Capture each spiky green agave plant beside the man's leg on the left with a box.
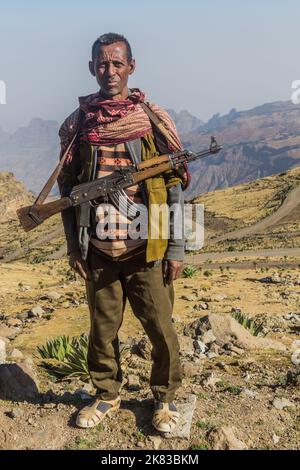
[37,334,89,378]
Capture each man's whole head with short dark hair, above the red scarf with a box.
[89,33,135,99]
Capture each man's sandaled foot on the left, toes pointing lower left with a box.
[76,397,121,428]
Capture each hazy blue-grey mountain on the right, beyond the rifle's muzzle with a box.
[181,102,300,199]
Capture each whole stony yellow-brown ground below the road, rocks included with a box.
[0,259,300,450]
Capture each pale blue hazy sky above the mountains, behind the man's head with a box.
[0,0,300,130]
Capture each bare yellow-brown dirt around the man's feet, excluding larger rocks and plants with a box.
[0,260,300,450]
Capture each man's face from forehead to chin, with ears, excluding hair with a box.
[89,42,135,98]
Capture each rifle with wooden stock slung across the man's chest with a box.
[17,136,222,232]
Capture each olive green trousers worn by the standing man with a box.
[86,249,181,402]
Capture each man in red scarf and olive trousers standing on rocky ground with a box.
[58,33,188,432]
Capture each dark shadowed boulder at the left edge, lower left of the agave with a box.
[0,363,39,401]
